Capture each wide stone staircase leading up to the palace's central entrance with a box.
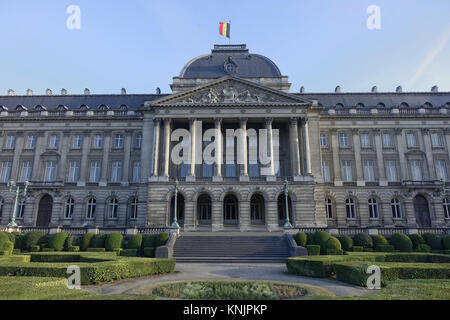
[173,232,289,263]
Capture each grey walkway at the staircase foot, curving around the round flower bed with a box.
[83,263,374,296]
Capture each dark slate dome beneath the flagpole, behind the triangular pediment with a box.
[179,44,282,79]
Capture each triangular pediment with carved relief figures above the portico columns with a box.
[150,77,313,105]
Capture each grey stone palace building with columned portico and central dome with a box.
[0,45,450,233]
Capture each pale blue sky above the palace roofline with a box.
[0,0,450,95]
